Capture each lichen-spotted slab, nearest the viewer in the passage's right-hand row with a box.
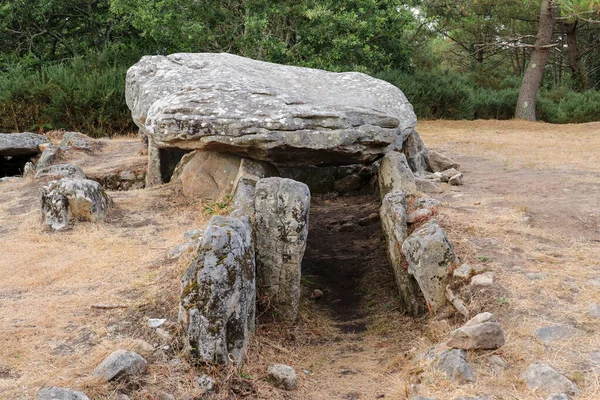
[402,220,458,312]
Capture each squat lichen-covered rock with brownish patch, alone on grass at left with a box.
[41,178,112,231]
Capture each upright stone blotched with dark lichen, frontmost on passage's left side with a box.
[179,216,256,364]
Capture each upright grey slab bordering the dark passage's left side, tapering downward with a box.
[254,178,310,322]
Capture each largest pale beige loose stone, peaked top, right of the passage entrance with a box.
[446,312,506,350]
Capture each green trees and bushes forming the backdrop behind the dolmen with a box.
[0,0,600,136]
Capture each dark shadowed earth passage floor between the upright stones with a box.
[302,195,387,333]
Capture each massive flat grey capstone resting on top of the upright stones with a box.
[126,53,418,183]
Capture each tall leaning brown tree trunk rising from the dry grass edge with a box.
[515,0,556,121]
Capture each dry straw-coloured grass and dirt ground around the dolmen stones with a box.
[0,121,600,400]
